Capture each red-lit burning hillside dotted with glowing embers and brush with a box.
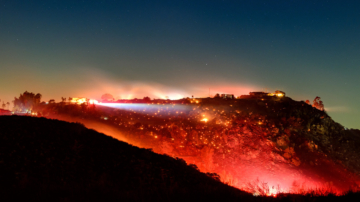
[31,94,360,195]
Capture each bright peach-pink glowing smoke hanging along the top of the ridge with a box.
[74,69,259,100]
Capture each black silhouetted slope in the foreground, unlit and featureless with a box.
[0,116,251,201]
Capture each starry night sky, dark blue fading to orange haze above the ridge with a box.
[0,0,360,128]
